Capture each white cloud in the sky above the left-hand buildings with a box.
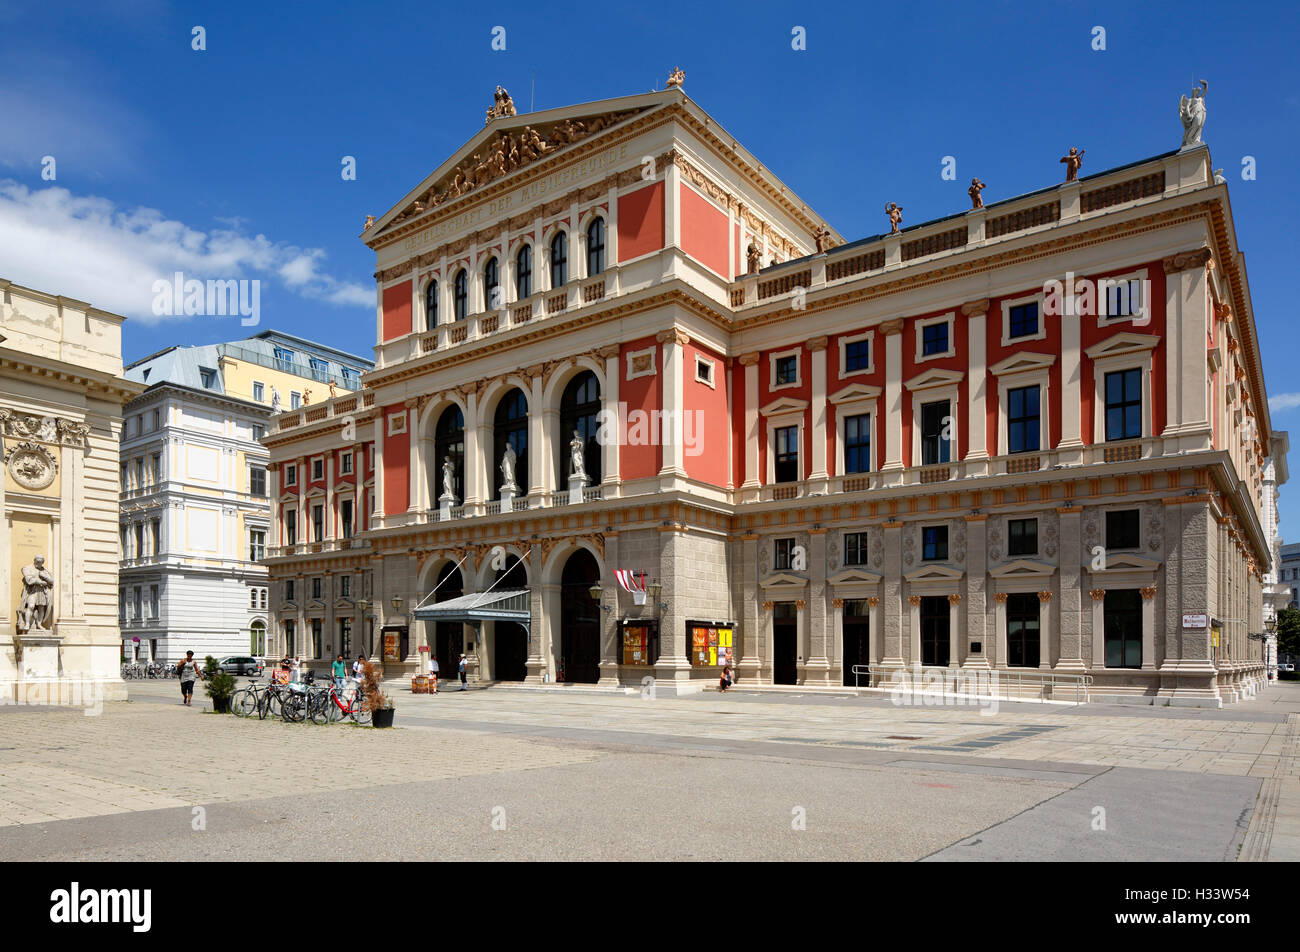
[0,179,374,323]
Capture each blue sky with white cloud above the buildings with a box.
[0,0,1300,528]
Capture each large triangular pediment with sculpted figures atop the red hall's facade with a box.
[361,90,677,241]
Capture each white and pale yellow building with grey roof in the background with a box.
[118,330,372,661]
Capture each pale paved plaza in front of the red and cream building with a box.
[0,681,1300,861]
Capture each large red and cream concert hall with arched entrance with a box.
[265,88,1270,705]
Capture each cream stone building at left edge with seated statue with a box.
[0,280,143,706]
